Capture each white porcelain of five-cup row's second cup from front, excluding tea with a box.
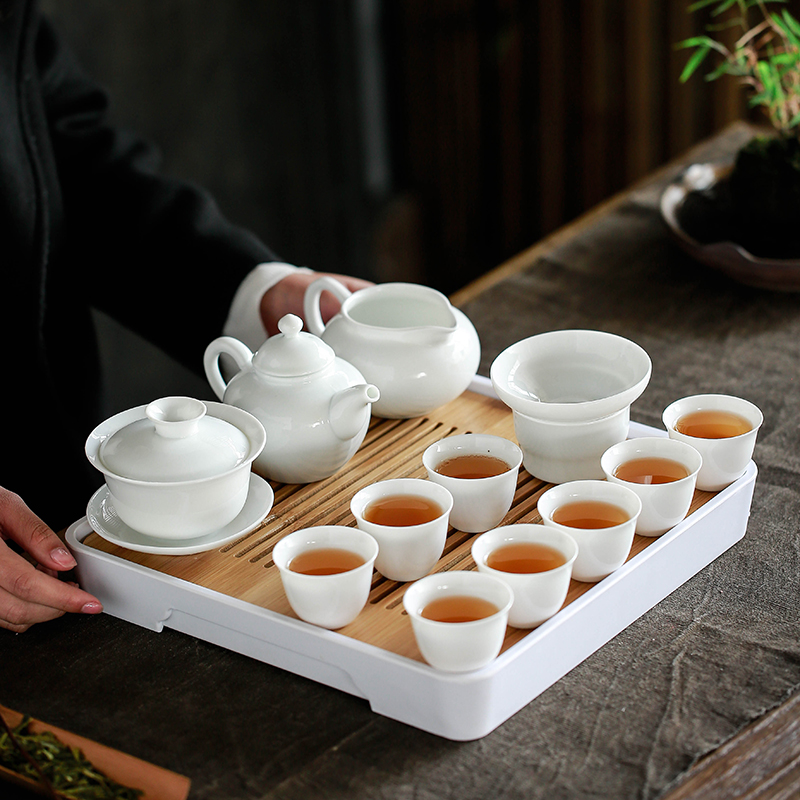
[472,523,578,628]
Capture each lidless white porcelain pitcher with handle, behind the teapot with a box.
[304,276,481,418]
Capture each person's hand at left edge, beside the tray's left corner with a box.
[0,486,103,633]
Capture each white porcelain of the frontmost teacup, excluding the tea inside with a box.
[403,570,514,672]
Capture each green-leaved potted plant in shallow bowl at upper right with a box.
[662,0,800,288]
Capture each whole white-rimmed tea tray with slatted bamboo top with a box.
[66,378,757,741]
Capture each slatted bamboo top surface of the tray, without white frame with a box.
[84,382,714,661]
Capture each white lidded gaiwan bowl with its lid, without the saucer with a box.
[85,397,266,539]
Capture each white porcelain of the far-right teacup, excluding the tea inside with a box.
[662,394,764,492]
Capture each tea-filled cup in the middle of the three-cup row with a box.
[350,478,453,581]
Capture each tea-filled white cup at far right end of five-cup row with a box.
[662,394,764,492]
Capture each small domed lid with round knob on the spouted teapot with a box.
[253,314,336,378]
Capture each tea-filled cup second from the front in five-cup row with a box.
[472,523,578,628]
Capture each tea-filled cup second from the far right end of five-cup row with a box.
[600,436,703,536]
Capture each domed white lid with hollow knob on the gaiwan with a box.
[98,397,250,482]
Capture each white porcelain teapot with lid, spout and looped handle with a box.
[203,314,380,483]
